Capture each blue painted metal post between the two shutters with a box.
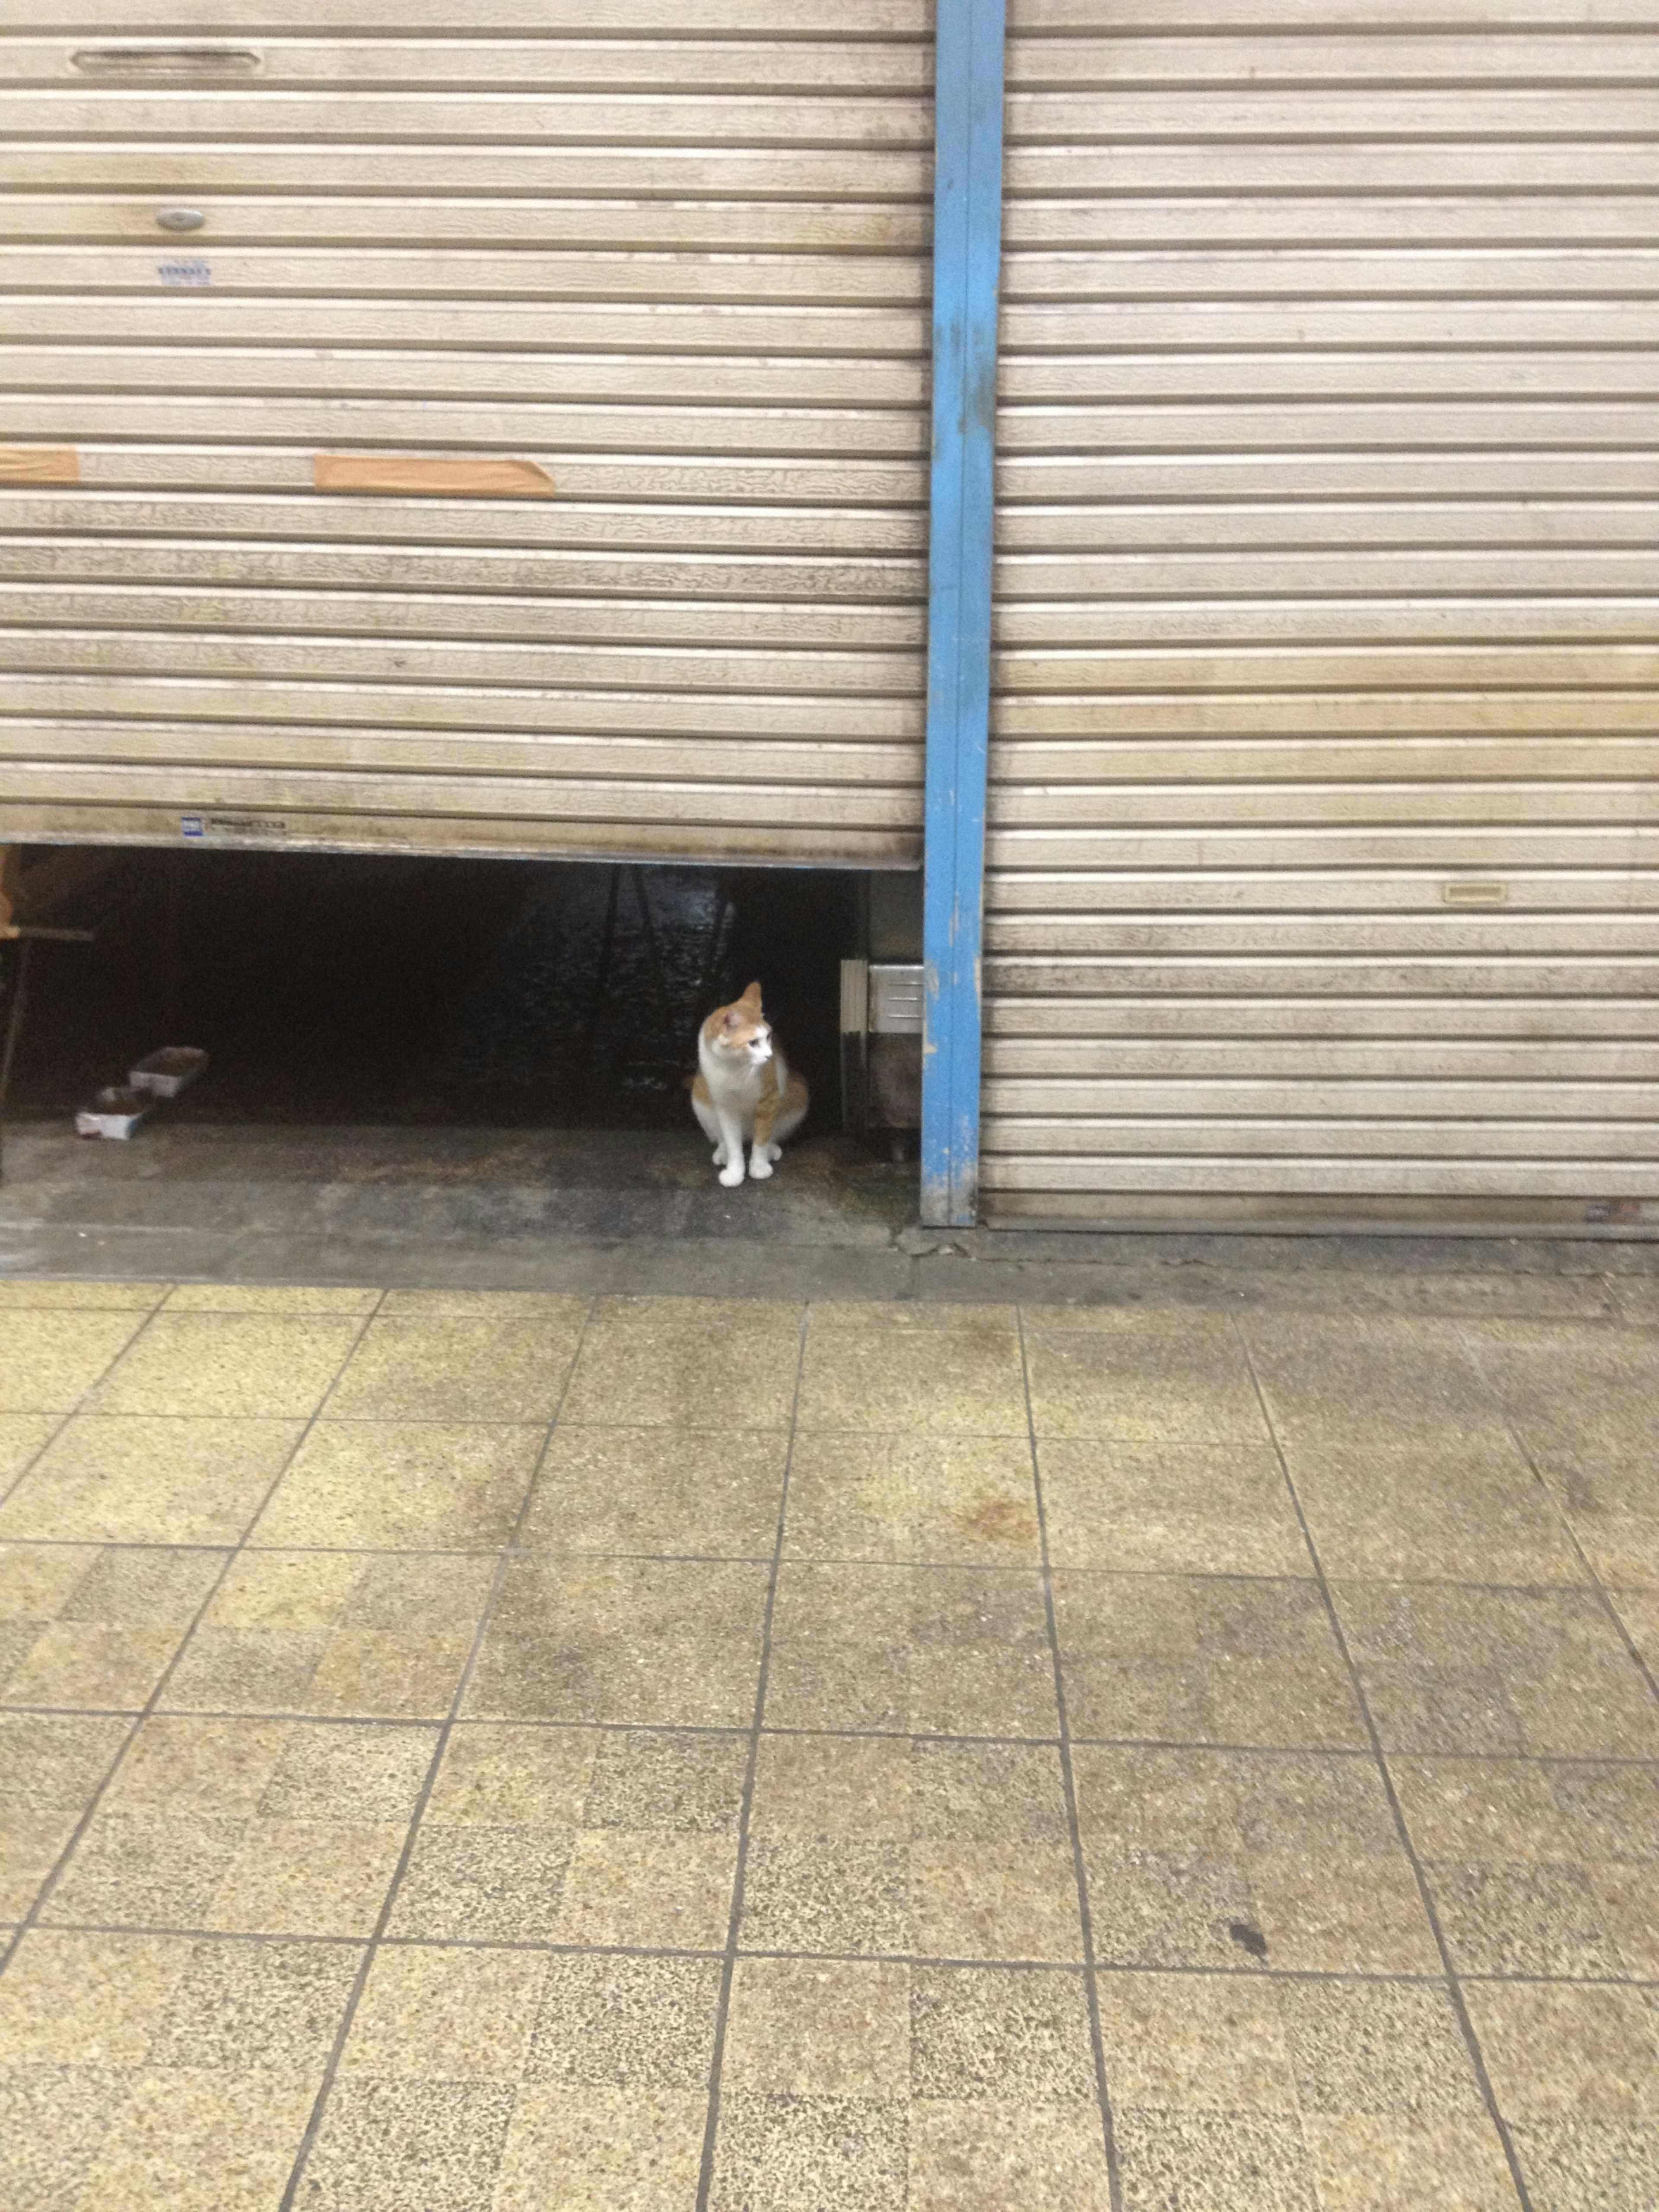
[922,0,1004,1225]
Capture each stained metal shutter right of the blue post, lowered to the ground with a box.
[984,0,1659,1221]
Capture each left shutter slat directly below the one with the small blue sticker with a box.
[6,299,938,354]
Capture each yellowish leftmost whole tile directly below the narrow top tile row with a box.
[93,1312,363,1420]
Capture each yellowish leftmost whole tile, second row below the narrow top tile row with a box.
[0,1414,303,1544]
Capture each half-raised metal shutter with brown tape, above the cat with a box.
[0,0,931,867]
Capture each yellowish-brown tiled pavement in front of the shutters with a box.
[0,1283,1659,2212]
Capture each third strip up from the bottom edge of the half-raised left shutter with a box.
[4,672,922,745]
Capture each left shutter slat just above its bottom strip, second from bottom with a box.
[0,717,920,788]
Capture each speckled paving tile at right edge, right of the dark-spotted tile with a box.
[1389,1758,1659,1977]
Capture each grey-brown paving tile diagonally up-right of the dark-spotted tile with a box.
[1332,1582,1659,1758]
